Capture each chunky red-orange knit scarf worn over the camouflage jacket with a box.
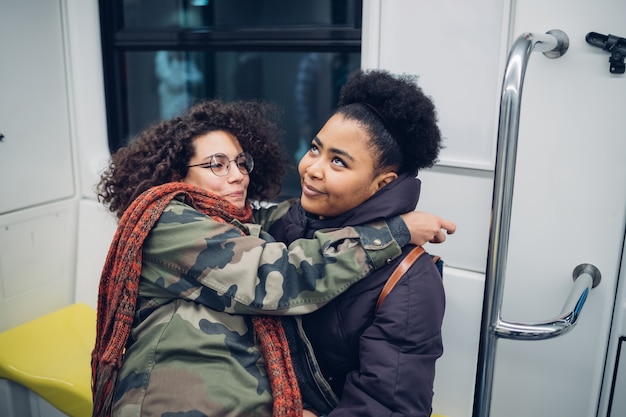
[91,182,302,417]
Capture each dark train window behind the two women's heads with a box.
[100,0,362,196]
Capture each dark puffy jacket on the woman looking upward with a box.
[270,176,445,417]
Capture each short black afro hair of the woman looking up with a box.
[336,70,442,174]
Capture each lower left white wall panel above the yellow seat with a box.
[0,200,77,331]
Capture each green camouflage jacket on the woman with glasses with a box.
[113,200,401,417]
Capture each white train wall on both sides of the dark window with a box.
[0,0,626,417]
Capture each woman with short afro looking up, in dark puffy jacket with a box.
[270,70,445,417]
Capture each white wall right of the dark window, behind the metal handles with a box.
[364,0,626,417]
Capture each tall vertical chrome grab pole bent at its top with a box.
[473,30,569,417]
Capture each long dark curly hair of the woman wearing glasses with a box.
[96,100,287,218]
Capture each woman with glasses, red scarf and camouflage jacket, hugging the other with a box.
[92,100,450,417]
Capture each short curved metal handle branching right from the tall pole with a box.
[494,264,601,340]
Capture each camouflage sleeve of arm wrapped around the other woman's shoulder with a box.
[143,206,401,314]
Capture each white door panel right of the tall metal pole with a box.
[491,0,626,417]
